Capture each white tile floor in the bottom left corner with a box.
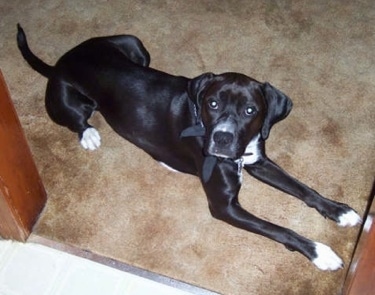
[0,240,198,295]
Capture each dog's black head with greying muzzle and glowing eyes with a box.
[188,73,292,159]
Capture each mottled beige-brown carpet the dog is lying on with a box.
[0,0,375,295]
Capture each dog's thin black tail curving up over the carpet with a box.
[17,24,53,78]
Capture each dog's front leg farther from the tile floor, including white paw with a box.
[244,156,361,226]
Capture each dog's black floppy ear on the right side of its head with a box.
[261,82,293,140]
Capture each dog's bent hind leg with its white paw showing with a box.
[46,78,100,150]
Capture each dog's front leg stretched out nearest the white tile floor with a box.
[202,160,342,270]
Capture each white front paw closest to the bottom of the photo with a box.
[312,242,344,270]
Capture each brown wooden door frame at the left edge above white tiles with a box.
[0,69,47,242]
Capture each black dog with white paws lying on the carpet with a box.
[17,26,361,270]
